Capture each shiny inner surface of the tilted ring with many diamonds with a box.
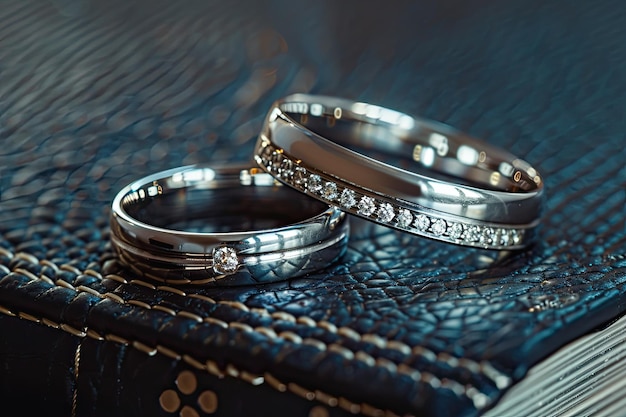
[283,103,541,192]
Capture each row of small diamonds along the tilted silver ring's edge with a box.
[260,145,524,247]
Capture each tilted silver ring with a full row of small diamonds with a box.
[255,94,543,250]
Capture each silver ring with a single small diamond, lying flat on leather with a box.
[111,166,349,285]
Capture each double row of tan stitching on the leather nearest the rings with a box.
[0,248,512,389]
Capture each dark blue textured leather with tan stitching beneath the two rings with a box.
[0,0,626,416]
